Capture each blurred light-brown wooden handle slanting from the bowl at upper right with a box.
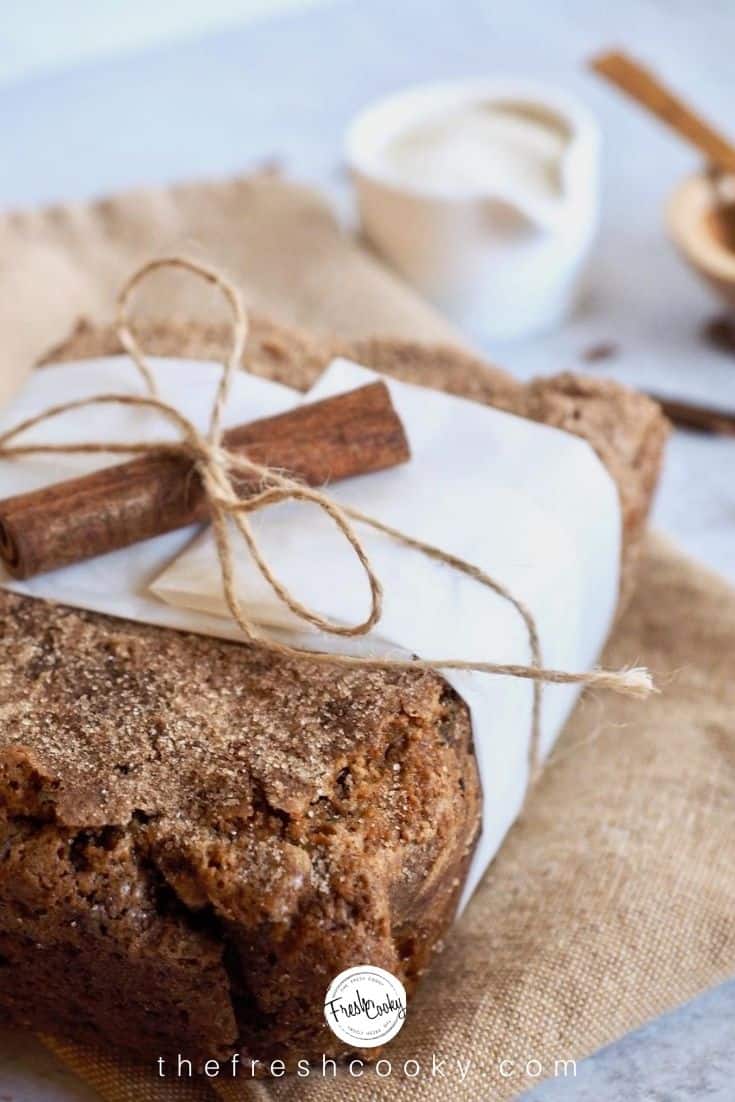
[590,50,735,172]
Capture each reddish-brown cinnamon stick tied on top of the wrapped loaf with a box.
[0,382,410,579]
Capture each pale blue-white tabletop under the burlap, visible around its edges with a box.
[0,0,735,1102]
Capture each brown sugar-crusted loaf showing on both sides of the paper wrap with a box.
[0,321,666,1061]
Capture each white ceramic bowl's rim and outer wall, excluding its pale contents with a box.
[346,80,601,339]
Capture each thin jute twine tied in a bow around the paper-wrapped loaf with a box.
[0,256,655,780]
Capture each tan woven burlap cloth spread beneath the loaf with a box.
[0,180,735,1102]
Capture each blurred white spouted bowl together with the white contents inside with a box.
[347,83,599,338]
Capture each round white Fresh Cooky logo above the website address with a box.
[324,964,406,1048]
